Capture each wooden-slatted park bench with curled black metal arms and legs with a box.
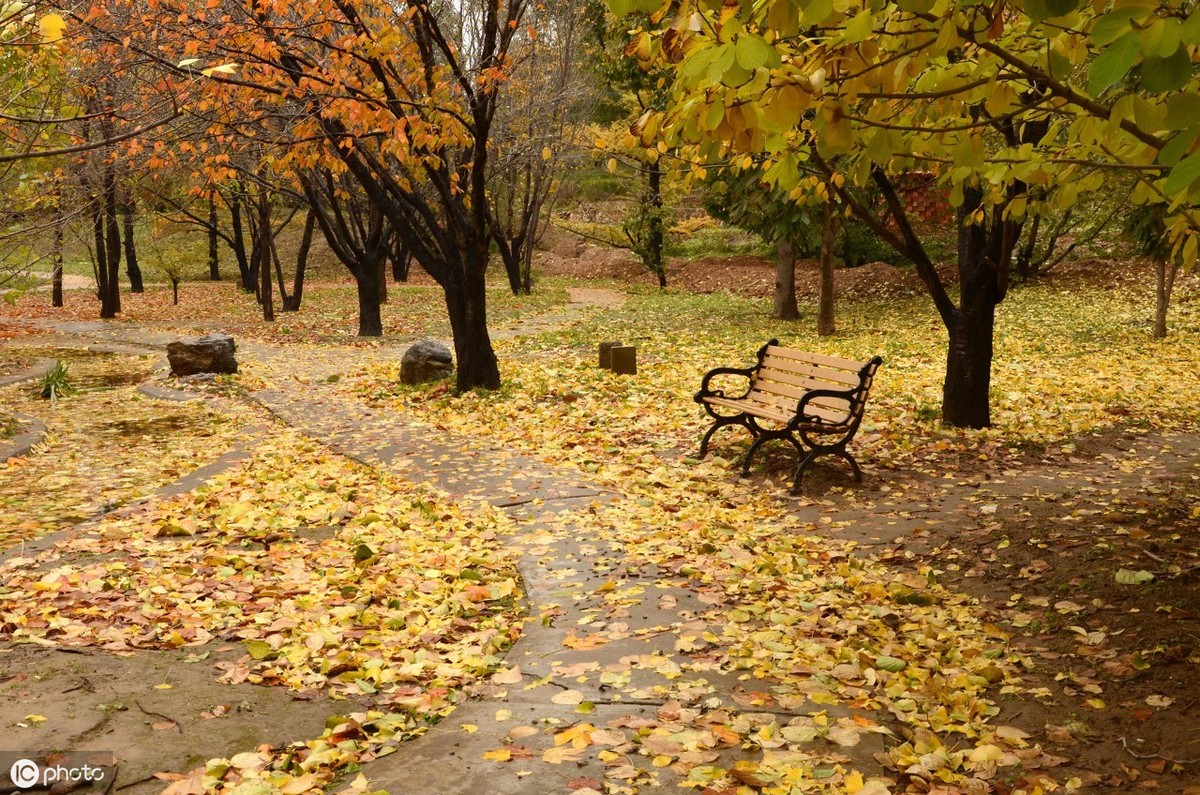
[696,340,883,494]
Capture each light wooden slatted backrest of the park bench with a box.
[750,340,882,425]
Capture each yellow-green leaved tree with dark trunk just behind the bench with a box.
[628,0,1200,428]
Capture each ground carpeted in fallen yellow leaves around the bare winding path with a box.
[0,256,1200,795]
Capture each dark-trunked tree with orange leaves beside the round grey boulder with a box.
[120,0,527,389]
